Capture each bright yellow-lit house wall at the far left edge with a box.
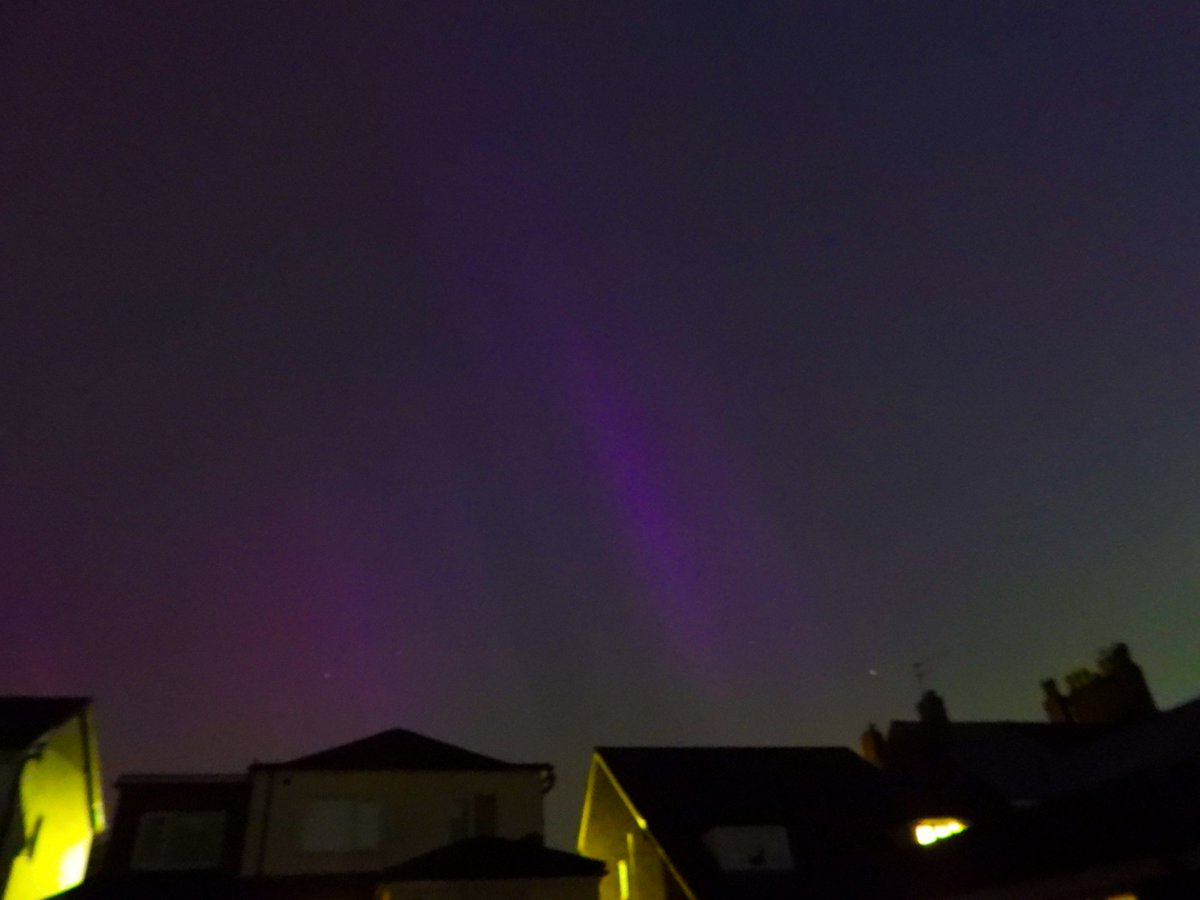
[4,718,103,900]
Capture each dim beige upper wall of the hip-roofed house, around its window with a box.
[242,769,544,875]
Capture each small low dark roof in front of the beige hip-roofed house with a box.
[380,838,605,882]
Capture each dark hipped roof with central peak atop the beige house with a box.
[259,728,553,772]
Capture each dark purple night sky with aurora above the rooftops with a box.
[0,0,1200,845]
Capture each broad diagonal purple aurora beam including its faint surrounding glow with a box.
[388,37,820,677]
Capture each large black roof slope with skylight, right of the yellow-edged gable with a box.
[596,746,920,899]
